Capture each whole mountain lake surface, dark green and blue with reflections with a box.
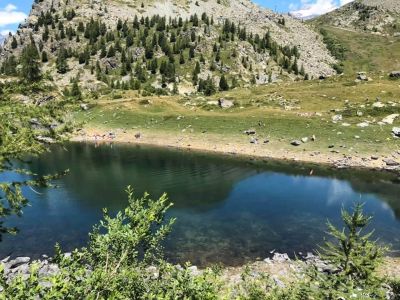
[0,143,400,266]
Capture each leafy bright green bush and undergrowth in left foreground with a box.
[0,188,218,299]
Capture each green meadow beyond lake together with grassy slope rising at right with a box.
[76,27,400,163]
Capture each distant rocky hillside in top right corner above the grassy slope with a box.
[312,0,400,37]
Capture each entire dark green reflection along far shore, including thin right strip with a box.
[28,143,400,218]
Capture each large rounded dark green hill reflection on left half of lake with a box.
[32,144,257,210]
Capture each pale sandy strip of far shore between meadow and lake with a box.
[70,127,400,175]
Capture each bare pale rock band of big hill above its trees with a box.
[18,0,335,76]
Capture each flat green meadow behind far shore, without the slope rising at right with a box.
[77,78,400,159]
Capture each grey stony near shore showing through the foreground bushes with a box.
[0,251,400,290]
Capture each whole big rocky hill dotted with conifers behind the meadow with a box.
[0,0,336,94]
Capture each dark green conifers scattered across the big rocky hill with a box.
[0,7,306,94]
